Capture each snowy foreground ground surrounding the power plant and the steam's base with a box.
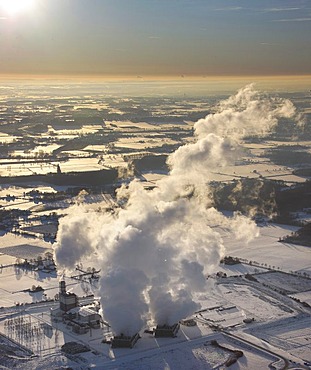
[0,224,311,370]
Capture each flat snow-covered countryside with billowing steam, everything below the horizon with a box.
[0,81,311,370]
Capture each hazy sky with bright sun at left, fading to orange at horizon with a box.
[0,0,311,77]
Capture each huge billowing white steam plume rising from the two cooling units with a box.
[55,85,295,335]
